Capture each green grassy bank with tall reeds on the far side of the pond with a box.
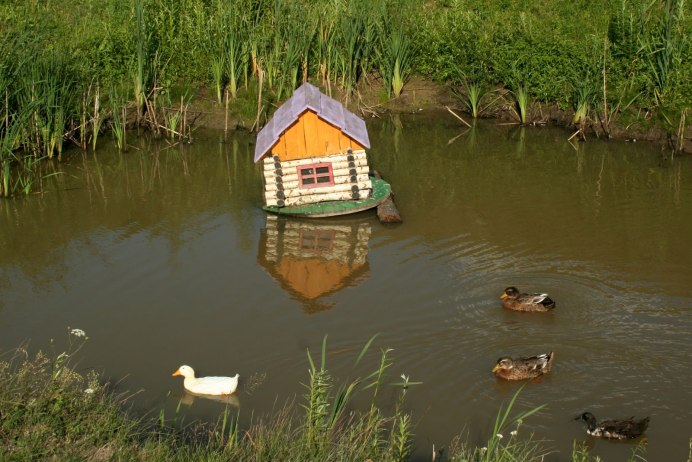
[0,0,692,196]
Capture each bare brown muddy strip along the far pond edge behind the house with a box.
[190,77,692,153]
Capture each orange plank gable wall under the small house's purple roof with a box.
[271,111,364,161]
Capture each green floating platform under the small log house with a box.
[262,177,392,218]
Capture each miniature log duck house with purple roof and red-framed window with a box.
[255,83,373,207]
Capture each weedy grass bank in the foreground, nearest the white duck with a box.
[0,329,676,462]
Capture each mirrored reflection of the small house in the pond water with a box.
[257,214,371,313]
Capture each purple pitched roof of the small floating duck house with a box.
[255,83,370,162]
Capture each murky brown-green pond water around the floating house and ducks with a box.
[0,114,692,461]
